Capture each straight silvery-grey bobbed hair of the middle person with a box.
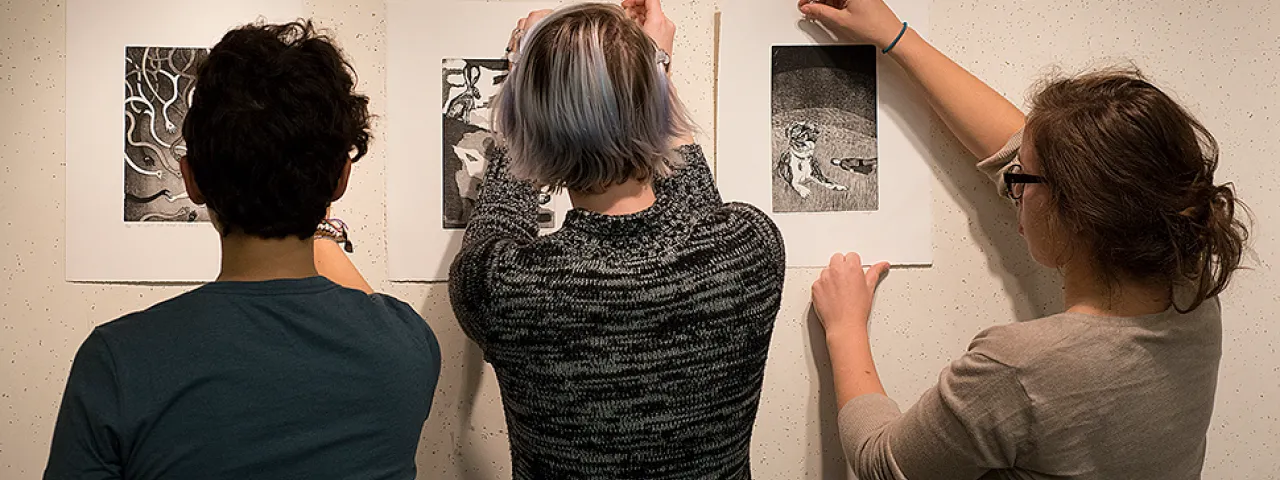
[493,4,692,193]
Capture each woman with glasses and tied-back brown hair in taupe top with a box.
[800,0,1248,480]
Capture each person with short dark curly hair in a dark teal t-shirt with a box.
[45,22,440,479]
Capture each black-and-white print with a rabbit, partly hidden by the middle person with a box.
[440,59,553,229]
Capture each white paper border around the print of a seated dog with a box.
[716,0,933,268]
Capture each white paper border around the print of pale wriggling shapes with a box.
[65,0,306,282]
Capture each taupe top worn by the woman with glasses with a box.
[840,134,1222,480]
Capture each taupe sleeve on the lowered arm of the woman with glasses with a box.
[840,351,1032,480]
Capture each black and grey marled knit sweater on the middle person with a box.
[449,146,786,479]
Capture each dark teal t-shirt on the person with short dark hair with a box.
[45,276,440,480]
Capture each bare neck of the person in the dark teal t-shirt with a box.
[216,233,319,282]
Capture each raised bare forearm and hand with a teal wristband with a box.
[800,0,1025,159]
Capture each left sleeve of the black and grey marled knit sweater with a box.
[449,148,538,348]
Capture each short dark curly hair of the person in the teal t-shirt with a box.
[182,20,370,238]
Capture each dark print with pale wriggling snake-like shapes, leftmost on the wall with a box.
[122,46,209,223]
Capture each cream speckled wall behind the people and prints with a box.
[0,0,1280,479]
